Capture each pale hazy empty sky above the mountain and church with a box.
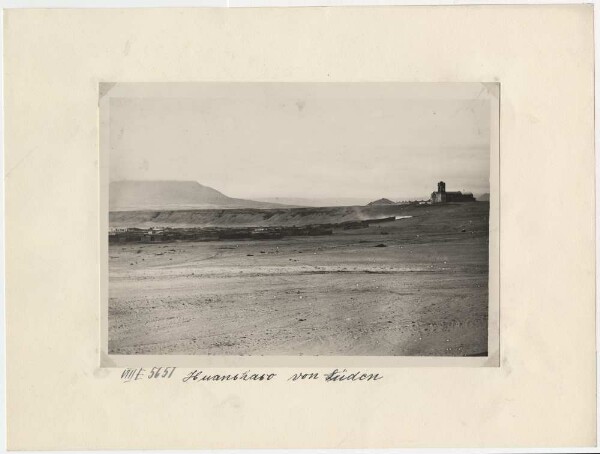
[109,84,491,199]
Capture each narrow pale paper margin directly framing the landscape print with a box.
[98,82,500,368]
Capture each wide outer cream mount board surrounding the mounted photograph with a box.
[4,5,596,449]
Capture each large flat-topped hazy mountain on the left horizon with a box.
[109,181,296,211]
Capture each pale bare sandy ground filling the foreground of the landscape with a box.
[109,203,489,356]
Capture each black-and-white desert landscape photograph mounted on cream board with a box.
[104,82,499,357]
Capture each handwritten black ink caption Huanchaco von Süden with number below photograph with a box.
[121,367,383,383]
